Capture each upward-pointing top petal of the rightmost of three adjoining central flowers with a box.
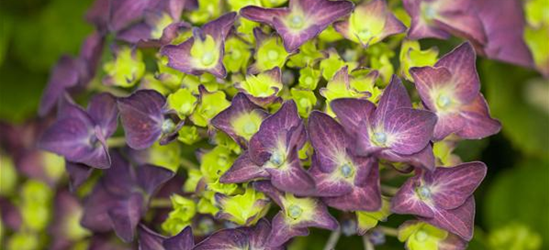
[372,75,412,124]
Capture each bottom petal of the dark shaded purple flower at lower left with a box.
[108,193,143,242]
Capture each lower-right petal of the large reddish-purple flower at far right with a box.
[457,94,501,140]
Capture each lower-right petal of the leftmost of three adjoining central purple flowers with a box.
[266,149,315,196]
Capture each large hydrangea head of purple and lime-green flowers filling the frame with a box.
[7,0,549,250]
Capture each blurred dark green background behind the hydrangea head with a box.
[0,0,549,250]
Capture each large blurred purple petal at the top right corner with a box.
[471,0,534,67]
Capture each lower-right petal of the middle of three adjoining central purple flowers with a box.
[322,164,381,211]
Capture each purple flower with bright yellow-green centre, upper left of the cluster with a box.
[160,12,236,78]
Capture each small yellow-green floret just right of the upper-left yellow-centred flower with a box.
[223,36,252,73]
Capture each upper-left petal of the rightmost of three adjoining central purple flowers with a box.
[330,98,376,136]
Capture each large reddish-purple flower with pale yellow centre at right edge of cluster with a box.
[410,43,501,140]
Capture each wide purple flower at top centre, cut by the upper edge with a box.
[240,0,353,52]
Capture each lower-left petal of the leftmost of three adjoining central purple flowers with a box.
[219,151,270,183]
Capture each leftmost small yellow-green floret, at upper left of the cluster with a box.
[103,46,145,88]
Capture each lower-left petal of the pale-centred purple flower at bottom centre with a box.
[268,211,309,247]
